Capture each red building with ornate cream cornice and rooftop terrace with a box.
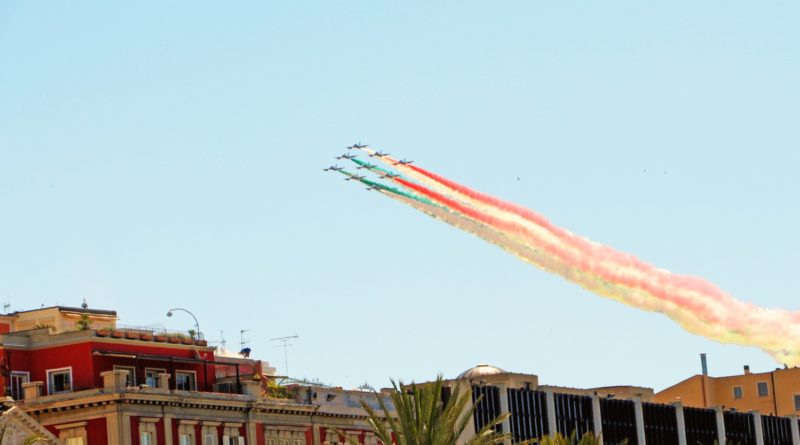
[0,307,388,445]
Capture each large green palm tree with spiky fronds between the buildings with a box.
[354,375,516,445]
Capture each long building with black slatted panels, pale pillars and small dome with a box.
[447,365,800,445]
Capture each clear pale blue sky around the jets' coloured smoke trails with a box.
[0,1,800,389]
